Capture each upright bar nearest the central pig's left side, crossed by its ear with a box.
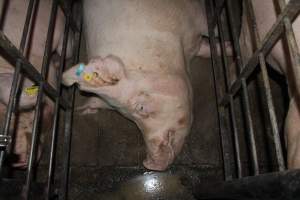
[61,3,82,200]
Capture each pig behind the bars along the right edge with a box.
[240,0,300,169]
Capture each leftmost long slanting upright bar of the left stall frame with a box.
[0,0,38,174]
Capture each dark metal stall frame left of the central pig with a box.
[0,0,82,200]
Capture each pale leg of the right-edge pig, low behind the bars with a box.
[285,98,300,169]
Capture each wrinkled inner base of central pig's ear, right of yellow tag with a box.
[90,55,126,86]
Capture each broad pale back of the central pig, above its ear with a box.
[84,0,206,71]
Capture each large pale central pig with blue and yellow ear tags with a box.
[63,0,208,171]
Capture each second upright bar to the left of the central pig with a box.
[46,15,71,200]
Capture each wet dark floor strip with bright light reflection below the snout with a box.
[69,166,222,200]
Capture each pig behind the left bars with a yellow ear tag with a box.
[0,0,72,168]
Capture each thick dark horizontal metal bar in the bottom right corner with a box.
[192,170,300,200]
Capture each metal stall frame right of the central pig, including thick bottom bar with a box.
[195,0,300,199]
